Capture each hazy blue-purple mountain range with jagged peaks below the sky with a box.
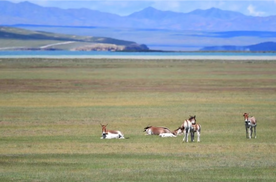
[0,0,276,31]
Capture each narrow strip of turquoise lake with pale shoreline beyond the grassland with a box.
[0,51,276,60]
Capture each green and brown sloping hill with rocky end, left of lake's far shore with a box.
[0,26,149,51]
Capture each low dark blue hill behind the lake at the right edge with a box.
[201,42,276,51]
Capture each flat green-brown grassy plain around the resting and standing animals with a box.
[0,58,276,182]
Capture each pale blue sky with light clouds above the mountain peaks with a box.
[8,0,276,16]
